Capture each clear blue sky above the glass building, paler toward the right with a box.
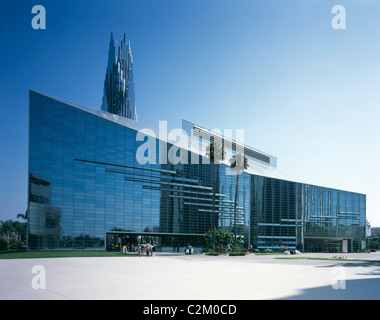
[0,0,380,226]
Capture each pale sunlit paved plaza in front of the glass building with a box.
[0,253,380,300]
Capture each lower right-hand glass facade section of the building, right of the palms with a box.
[251,176,366,251]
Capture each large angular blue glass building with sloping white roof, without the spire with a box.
[27,91,366,252]
